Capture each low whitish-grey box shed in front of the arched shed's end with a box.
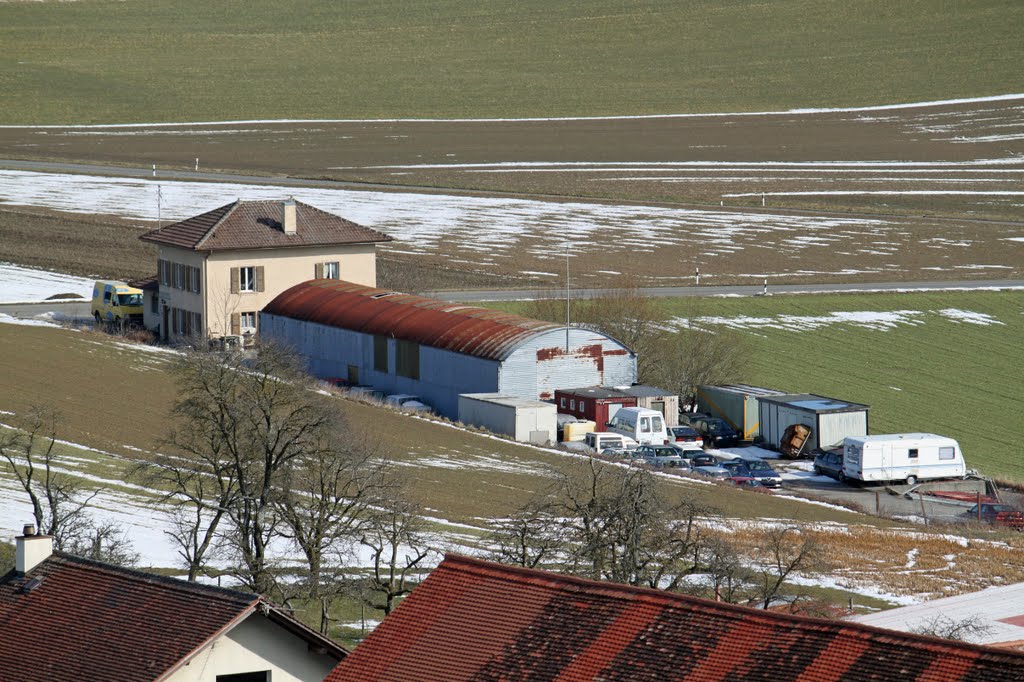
[459,393,558,445]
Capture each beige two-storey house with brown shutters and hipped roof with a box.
[139,199,391,341]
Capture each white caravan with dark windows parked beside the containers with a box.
[843,433,967,485]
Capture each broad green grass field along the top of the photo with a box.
[0,0,1024,124]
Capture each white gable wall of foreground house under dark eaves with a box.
[166,612,337,682]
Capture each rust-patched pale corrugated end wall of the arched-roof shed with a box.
[498,328,637,400]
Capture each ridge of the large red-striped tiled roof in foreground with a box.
[438,553,1024,662]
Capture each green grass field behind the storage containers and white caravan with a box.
[675,292,1024,481]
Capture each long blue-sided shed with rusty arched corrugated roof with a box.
[260,280,637,419]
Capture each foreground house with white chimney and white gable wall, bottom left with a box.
[0,526,346,682]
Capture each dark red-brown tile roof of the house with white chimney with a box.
[0,552,344,682]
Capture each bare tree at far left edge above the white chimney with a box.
[0,407,99,550]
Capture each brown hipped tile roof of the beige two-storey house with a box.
[139,200,391,251]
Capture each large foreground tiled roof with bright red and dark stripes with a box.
[326,554,1024,682]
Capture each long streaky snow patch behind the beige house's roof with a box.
[0,171,892,265]
